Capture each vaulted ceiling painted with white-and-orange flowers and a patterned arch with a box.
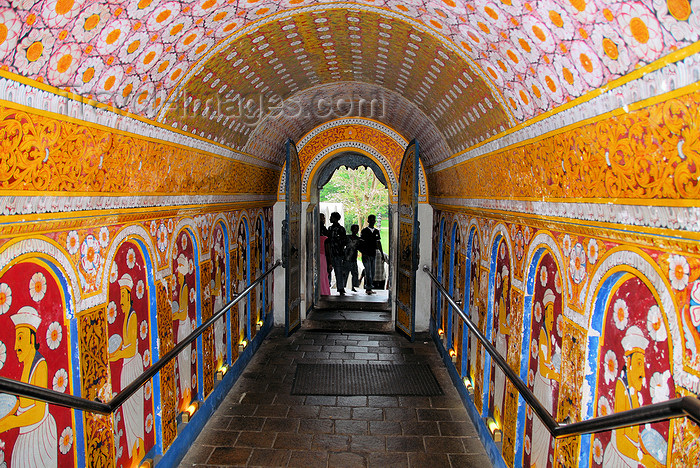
[0,0,700,165]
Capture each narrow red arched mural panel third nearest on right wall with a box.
[489,239,511,427]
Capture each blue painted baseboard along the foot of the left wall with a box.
[156,313,274,468]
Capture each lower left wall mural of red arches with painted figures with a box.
[0,206,274,467]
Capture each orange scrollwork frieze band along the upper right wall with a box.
[428,87,700,205]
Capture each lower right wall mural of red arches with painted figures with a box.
[432,206,700,467]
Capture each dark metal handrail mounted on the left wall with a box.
[0,260,282,414]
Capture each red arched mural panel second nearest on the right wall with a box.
[523,253,564,468]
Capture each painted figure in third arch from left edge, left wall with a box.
[172,254,192,411]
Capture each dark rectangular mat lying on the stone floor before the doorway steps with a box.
[292,363,443,396]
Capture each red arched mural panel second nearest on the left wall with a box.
[107,242,155,466]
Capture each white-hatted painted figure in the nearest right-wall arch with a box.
[603,325,665,468]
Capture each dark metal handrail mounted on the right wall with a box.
[423,265,700,439]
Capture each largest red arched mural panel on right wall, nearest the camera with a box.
[592,275,680,467]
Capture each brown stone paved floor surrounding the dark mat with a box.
[180,327,491,468]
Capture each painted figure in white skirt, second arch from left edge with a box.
[109,273,145,465]
